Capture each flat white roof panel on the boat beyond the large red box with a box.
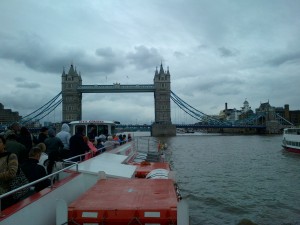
[70,153,136,178]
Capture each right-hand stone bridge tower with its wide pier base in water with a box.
[151,64,176,136]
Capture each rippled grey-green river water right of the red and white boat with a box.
[134,133,300,225]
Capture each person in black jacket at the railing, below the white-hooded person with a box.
[21,147,51,192]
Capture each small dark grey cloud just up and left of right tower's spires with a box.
[127,45,163,70]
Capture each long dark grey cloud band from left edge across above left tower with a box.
[0,31,124,75]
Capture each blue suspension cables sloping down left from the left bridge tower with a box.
[20,92,62,123]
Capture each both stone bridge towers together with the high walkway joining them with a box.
[61,64,176,136]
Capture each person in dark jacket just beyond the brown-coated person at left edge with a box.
[5,130,28,165]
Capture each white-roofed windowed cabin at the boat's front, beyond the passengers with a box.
[69,120,116,136]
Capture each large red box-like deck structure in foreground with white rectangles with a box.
[68,179,178,224]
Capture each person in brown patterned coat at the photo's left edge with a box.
[0,136,18,210]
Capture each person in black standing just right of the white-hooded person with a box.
[70,126,89,162]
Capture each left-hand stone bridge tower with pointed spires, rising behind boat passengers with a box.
[61,65,82,121]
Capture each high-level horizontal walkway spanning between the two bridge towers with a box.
[77,83,155,93]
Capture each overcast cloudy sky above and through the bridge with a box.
[0,0,300,123]
